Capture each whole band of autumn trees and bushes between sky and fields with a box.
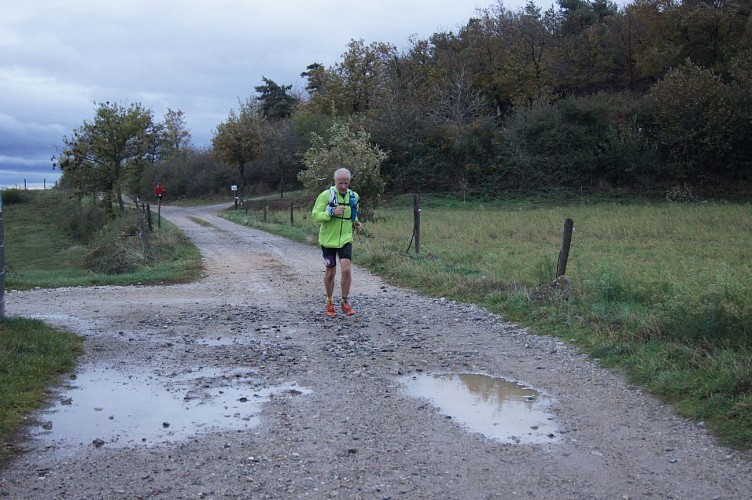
[55,0,752,206]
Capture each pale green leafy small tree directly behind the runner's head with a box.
[298,121,387,220]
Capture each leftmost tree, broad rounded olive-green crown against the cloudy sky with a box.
[58,102,160,212]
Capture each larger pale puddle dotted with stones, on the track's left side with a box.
[32,367,311,454]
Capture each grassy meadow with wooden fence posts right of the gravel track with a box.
[225,191,752,449]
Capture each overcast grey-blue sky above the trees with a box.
[0,0,536,188]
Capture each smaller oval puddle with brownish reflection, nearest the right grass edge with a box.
[401,373,559,444]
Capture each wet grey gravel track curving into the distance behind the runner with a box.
[0,201,752,499]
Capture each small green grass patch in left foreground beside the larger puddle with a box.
[0,318,81,458]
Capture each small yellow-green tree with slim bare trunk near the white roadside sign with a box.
[212,99,261,199]
